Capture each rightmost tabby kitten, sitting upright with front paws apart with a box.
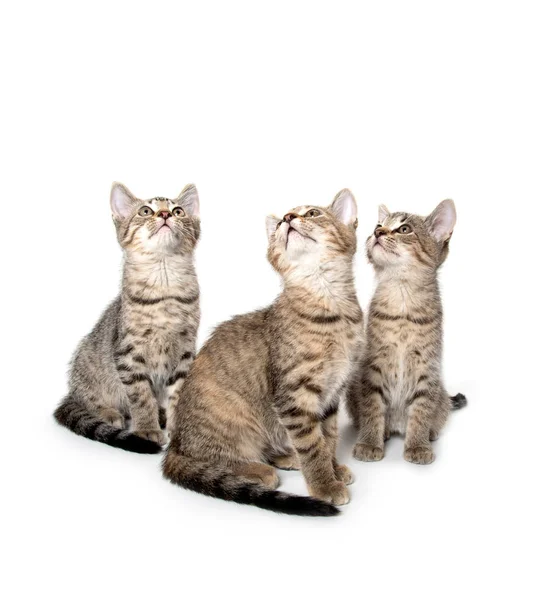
[347,200,466,464]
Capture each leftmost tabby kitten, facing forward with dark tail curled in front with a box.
[54,183,200,453]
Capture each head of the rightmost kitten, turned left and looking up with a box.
[366,200,456,272]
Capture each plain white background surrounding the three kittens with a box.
[0,0,554,600]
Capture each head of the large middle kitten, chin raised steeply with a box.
[266,190,358,275]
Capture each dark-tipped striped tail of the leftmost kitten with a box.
[54,396,162,454]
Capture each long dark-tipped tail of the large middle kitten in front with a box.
[163,449,340,517]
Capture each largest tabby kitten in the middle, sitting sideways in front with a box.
[163,190,363,516]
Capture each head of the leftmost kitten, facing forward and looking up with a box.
[110,183,200,254]
